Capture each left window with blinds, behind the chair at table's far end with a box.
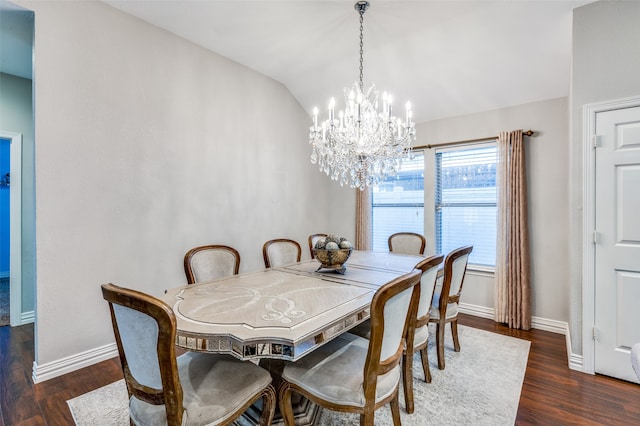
[371,152,424,251]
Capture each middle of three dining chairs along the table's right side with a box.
[402,255,444,414]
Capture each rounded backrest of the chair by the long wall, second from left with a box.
[184,245,240,284]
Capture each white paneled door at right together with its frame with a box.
[583,99,640,383]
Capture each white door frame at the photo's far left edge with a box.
[0,130,22,327]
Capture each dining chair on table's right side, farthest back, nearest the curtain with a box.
[429,246,473,370]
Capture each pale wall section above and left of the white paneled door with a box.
[568,1,640,354]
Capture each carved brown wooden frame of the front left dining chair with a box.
[102,283,276,426]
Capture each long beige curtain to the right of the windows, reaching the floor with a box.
[495,130,531,330]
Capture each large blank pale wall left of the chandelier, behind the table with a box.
[18,0,355,376]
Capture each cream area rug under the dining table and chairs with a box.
[67,326,530,426]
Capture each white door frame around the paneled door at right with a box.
[582,96,640,374]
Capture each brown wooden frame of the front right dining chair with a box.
[279,270,422,426]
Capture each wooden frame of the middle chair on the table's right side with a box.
[402,255,444,414]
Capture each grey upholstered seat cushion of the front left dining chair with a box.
[129,352,271,426]
